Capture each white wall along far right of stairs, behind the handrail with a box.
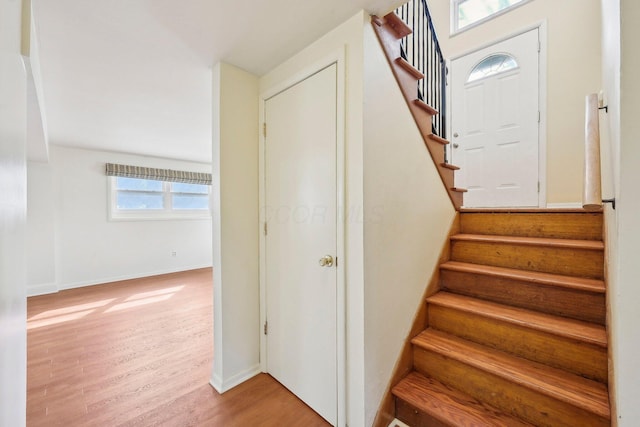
[602,0,640,427]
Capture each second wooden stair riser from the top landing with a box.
[451,240,604,279]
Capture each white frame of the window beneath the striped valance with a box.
[107,176,212,221]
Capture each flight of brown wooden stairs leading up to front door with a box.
[392,209,610,427]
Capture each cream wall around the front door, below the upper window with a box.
[428,0,601,204]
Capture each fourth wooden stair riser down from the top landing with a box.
[429,304,608,383]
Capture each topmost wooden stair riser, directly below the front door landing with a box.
[460,212,603,240]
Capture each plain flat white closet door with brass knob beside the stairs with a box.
[265,64,338,425]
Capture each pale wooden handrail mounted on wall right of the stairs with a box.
[582,93,602,211]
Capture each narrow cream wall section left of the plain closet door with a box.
[211,63,260,392]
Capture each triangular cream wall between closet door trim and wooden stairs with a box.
[364,25,455,426]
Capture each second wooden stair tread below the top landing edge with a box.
[440,261,606,294]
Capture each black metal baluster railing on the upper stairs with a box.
[395,0,448,140]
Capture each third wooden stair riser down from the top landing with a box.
[440,269,606,325]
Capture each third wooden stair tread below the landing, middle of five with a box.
[427,292,607,348]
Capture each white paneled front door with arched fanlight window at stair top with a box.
[451,29,539,207]
